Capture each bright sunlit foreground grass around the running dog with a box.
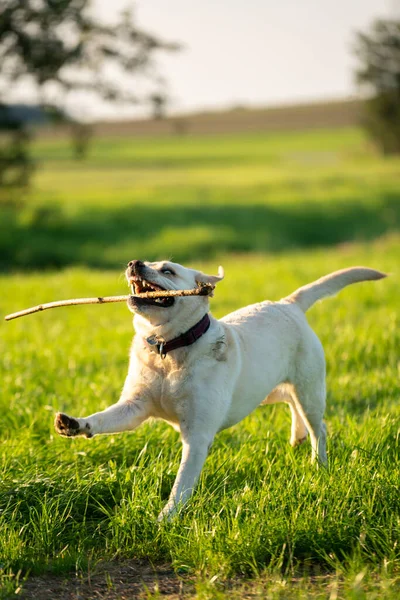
[0,238,400,593]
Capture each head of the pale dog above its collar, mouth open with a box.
[125,260,224,327]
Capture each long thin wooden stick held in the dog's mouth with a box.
[4,283,214,321]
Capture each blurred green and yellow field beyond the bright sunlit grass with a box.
[0,129,400,270]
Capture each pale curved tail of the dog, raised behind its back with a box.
[285,267,386,312]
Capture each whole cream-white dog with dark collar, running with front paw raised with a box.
[55,260,386,520]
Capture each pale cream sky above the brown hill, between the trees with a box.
[6,0,400,120]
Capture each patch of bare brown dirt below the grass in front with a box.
[19,560,194,600]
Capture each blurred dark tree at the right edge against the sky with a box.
[355,20,400,154]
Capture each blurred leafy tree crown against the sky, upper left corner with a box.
[0,0,179,169]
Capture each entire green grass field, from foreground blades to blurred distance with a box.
[0,130,400,600]
